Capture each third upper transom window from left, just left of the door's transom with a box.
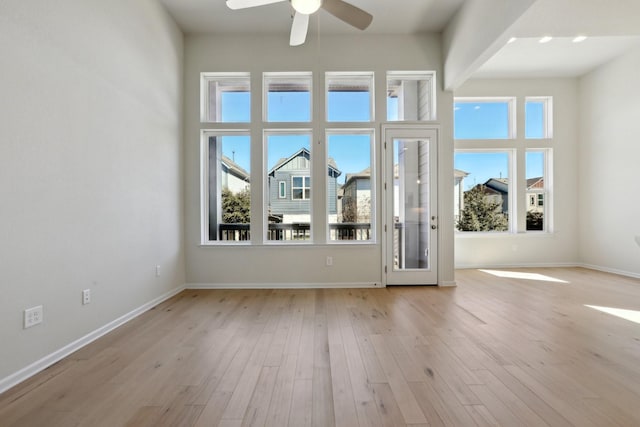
[325,72,373,122]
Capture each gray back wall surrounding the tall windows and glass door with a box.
[185,34,453,286]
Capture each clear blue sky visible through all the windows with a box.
[216,92,544,189]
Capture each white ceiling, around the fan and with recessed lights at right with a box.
[160,0,640,78]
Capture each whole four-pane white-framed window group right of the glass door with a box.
[454,97,553,233]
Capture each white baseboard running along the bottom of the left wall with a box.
[0,286,185,393]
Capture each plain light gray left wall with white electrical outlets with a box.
[0,0,185,388]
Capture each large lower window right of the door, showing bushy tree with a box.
[454,150,513,232]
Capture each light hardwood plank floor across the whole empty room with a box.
[0,268,640,427]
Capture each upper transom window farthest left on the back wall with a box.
[200,73,251,123]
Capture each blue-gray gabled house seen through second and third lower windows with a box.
[268,148,342,223]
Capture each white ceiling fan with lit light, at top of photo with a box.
[227,0,373,46]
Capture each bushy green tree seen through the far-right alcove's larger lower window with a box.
[456,185,509,231]
